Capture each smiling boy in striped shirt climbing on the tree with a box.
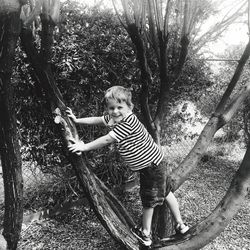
[67,86,189,246]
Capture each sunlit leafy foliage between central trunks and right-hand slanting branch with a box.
[162,55,216,145]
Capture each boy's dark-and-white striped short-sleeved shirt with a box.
[103,113,163,171]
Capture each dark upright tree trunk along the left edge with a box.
[0,1,23,249]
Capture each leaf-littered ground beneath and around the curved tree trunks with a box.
[2,141,250,250]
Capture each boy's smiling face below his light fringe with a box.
[107,99,132,123]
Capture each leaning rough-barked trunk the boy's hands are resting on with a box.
[21,16,139,250]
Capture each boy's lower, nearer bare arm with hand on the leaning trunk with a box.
[68,134,115,153]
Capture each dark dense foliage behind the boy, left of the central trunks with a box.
[15,1,138,188]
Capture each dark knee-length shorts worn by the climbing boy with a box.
[140,163,172,208]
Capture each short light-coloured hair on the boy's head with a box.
[104,86,134,110]
